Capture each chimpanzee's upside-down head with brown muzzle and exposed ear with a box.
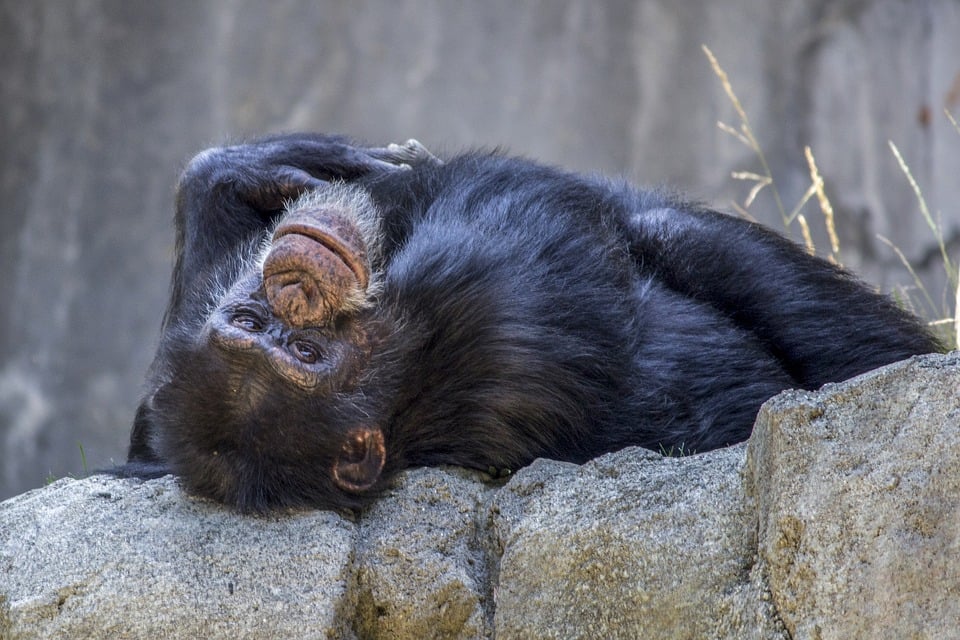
[153,188,386,511]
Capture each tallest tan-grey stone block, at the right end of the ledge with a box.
[749,353,960,639]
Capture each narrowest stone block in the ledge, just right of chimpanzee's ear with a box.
[356,469,492,640]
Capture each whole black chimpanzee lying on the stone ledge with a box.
[118,134,938,512]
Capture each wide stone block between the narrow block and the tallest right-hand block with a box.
[491,445,776,640]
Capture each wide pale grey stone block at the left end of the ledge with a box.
[0,476,356,640]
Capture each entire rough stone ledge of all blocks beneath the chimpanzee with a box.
[0,353,960,640]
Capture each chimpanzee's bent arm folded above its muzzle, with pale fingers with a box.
[166,134,429,325]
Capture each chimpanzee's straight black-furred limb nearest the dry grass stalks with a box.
[628,194,938,388]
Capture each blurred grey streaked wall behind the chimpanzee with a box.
[0,0,960,499]
